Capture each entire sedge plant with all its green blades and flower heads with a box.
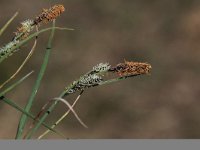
[0,4,151,139]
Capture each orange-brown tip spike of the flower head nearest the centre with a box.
[110,61,152,76]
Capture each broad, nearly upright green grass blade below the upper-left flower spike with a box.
[16,21,55,139]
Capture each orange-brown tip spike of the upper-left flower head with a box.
[34,5,65,25]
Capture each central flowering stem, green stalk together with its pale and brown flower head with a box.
[27,62,151,139]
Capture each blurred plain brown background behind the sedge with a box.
[0,0,200,139]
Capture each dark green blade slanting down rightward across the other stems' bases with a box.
[1,97,65,138]
